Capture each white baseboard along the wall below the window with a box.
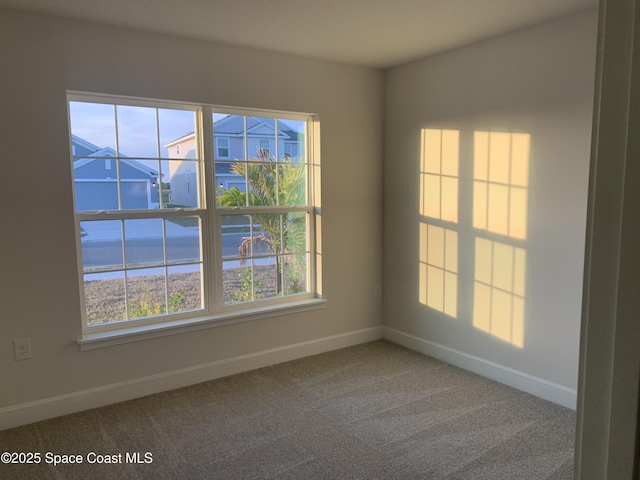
[0,326,383,430]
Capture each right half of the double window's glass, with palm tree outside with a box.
[213,113,311,305]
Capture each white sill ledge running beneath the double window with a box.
[76,298,326,351]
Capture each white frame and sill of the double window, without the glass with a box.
[67,91,325,350]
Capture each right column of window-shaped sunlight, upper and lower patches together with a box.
[473,132,531,348]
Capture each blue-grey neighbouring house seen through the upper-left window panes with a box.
[71,135,160,211]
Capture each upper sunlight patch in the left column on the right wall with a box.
[420,129,460,223]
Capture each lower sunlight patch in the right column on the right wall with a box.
[473,238,527,348]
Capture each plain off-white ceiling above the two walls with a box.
[0,0,597,68]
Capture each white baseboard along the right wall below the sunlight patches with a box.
[384,327,578,410]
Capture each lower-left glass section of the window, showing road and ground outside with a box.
[80,213,203,325]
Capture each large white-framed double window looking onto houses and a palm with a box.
[68,93,316,342]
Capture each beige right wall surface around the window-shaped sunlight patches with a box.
[384,11,597,390]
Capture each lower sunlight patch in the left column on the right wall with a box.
[419,223,458,317]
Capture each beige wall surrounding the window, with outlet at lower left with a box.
[0,9,383,408]
